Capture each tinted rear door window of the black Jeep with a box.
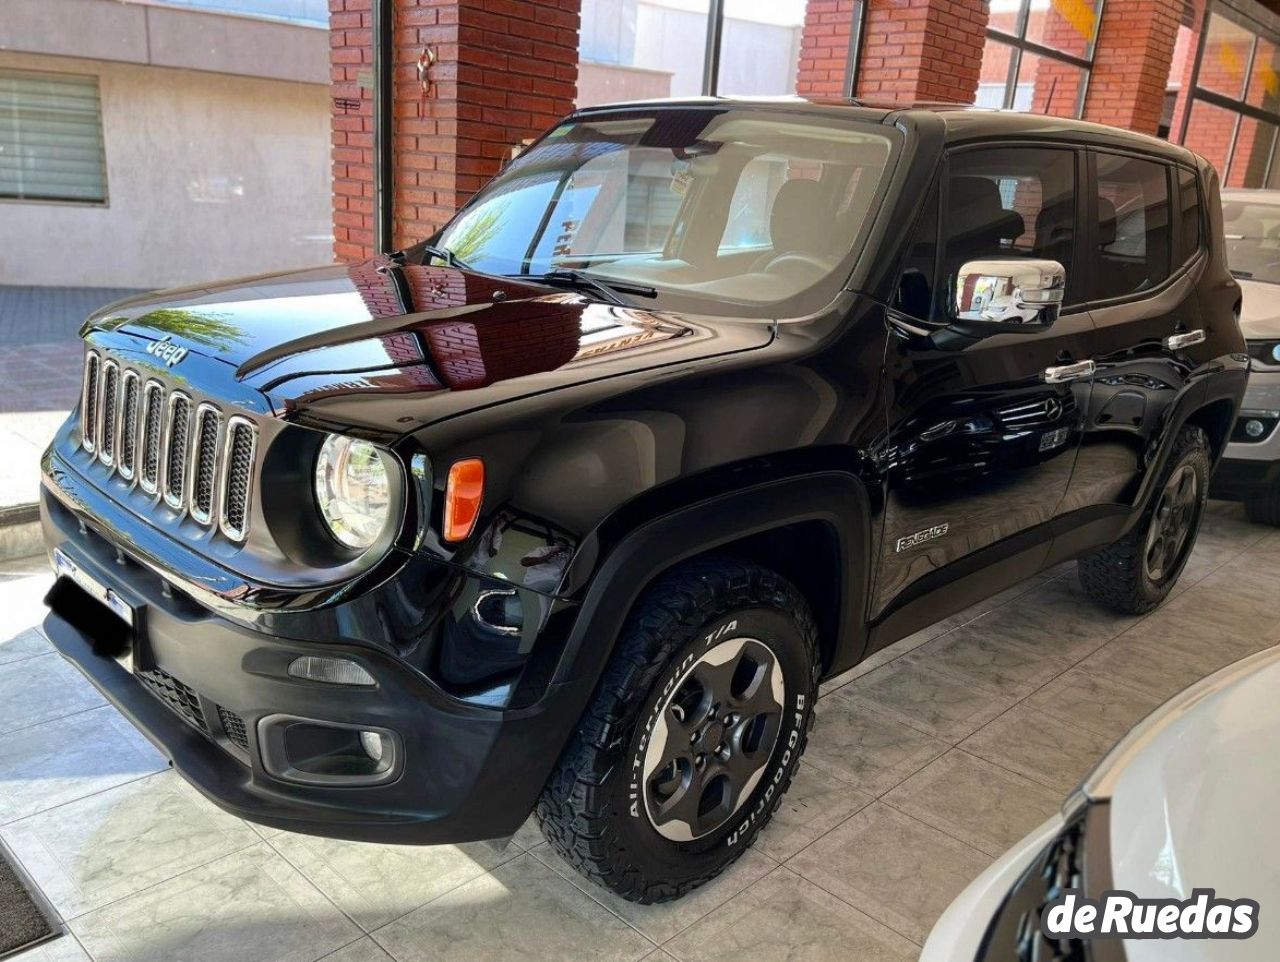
[1093,154,1170,299]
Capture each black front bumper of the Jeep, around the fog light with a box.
[41,465,590,844]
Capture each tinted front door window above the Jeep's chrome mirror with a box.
[942,147,1076,300]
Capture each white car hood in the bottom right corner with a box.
[1085,649,1280,962]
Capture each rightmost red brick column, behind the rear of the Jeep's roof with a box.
[1084,0,1181,134]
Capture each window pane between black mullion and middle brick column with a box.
[716,0,808,96]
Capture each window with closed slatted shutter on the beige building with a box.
[0,69,106,203]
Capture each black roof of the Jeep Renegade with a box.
[576,96,1196,164]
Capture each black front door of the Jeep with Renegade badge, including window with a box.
[872,146,1092,618]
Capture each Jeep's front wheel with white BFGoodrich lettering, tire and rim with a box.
[536,558,818,902]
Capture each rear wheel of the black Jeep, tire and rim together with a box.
[1076,426,1210,614]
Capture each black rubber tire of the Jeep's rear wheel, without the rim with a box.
[1076,426,1210,614]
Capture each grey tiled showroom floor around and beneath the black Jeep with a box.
[0,505,1280,962]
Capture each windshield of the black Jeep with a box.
[438,107,896,316]
